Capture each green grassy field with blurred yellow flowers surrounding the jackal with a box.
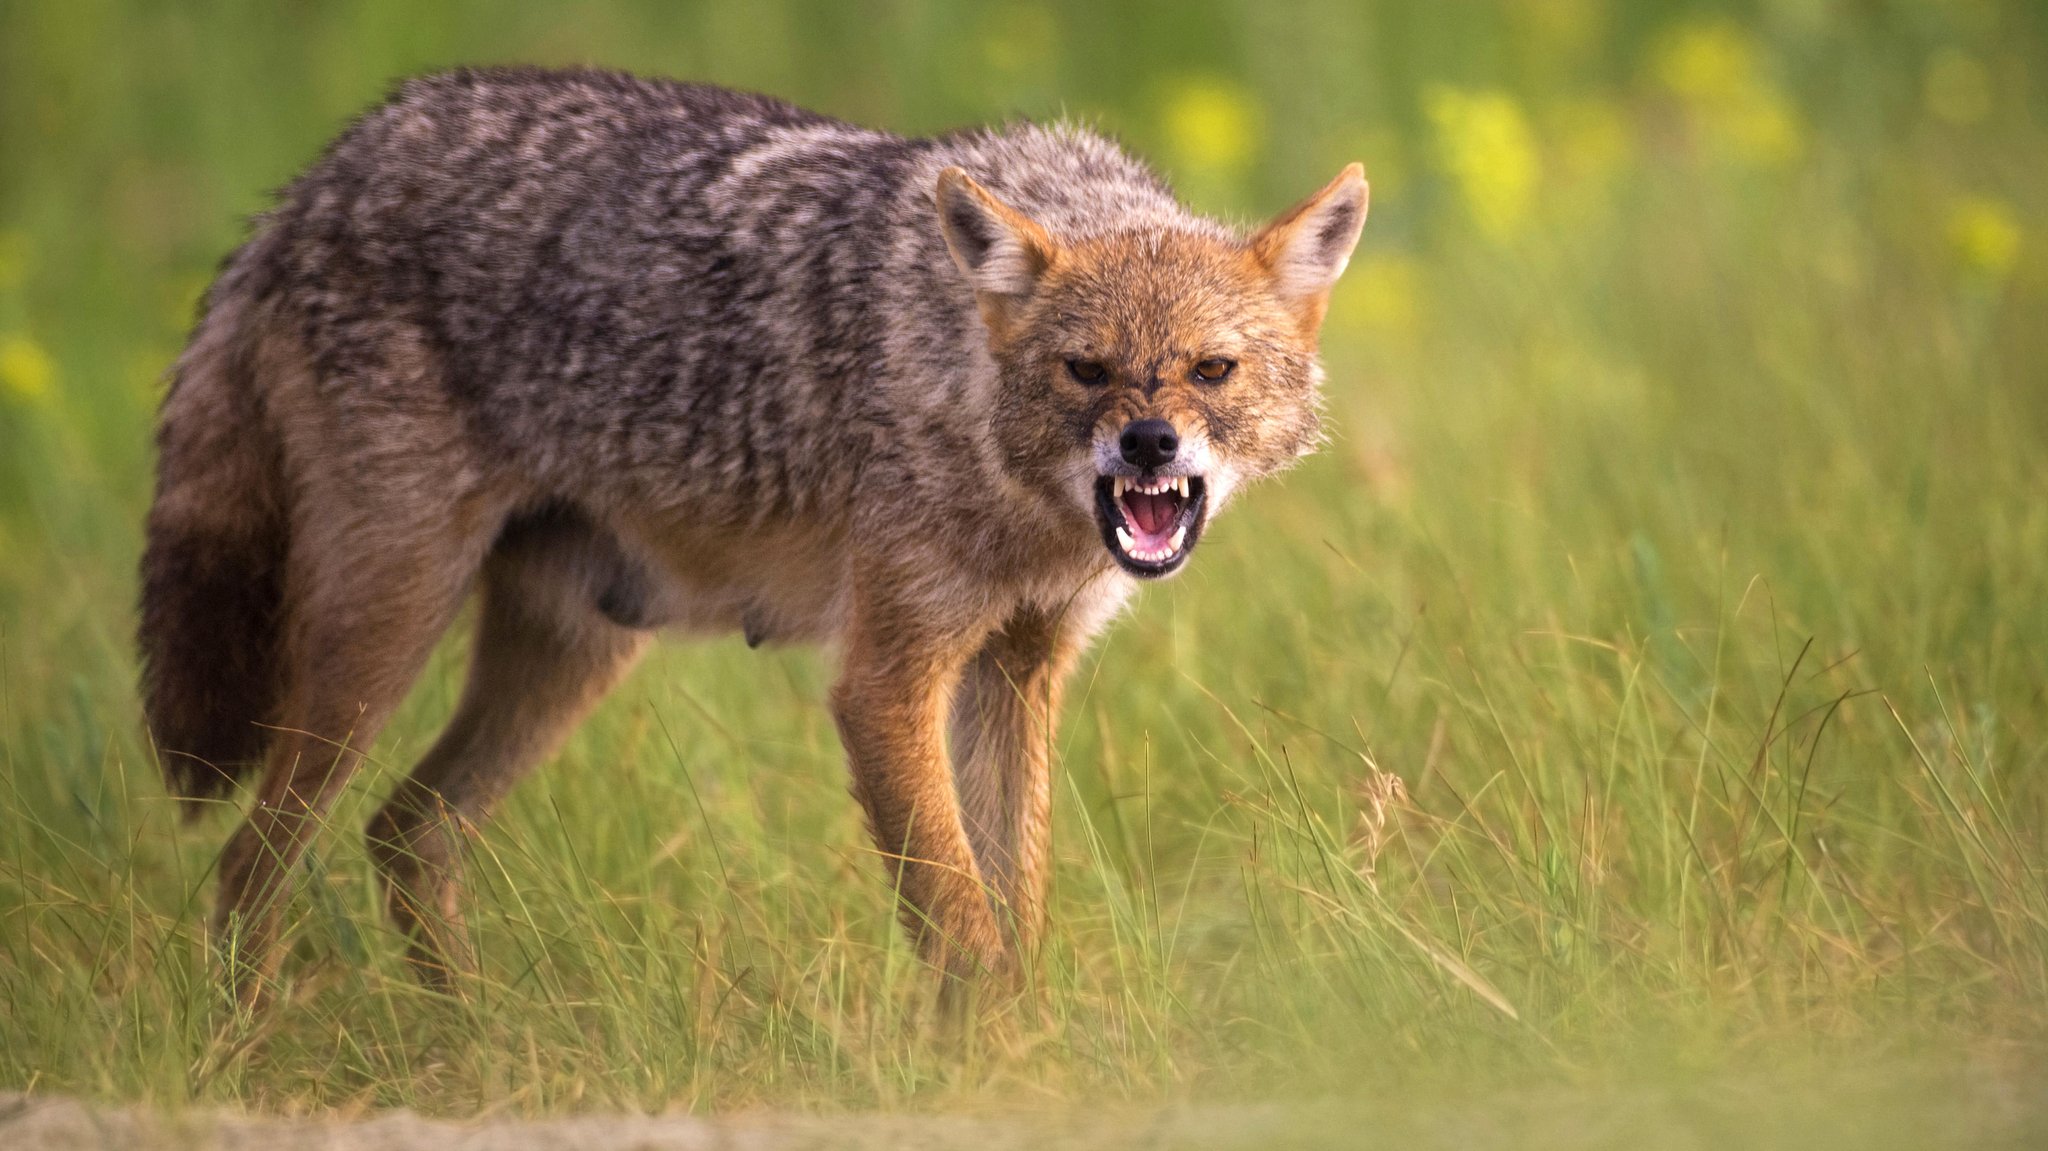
[0,0,2048,1133]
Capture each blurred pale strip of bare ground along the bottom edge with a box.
[12,1067,2048,1151]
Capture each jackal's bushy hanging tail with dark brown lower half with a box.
[139,286,289,801]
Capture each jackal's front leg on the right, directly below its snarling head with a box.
[950,608,1075,971]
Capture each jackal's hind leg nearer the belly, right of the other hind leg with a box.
[367,509,651,989]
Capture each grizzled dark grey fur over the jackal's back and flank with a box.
[260,72,1188,522]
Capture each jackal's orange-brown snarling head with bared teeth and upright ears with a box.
[938,164,1366,578]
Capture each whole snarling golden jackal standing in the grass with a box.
[141,72,1366,999]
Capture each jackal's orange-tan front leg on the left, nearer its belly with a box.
[831,602,1010,979]
